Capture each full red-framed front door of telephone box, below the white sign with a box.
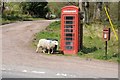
[62,15,77,54]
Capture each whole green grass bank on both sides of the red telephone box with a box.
[33,21,120,62]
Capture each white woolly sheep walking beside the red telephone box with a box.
[36,39,58,54]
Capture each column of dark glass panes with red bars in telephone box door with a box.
[64,15,75,53]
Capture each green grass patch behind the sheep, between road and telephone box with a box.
[33,21,60,46]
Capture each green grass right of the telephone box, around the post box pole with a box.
[79,24,118,61]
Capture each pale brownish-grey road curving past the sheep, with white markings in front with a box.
[0,20,118,78]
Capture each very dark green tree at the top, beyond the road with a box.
[21,2,49,17]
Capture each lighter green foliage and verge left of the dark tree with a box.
[2,2,47,24]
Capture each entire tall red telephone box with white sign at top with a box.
[60,6,81,54]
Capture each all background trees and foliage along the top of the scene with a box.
[1,2,119,24]
